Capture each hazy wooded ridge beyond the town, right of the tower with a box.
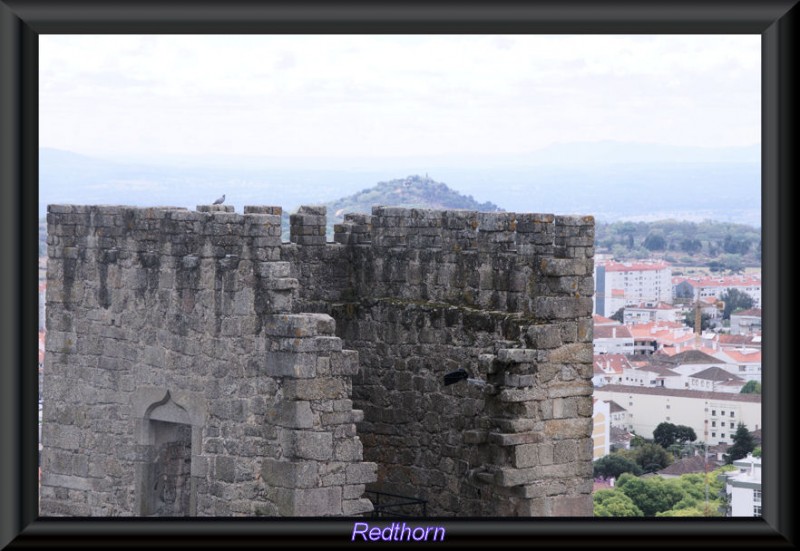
[595,220,761,271]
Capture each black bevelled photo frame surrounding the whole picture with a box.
[0,0,800,549]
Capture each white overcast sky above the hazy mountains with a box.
[39,35,761,157]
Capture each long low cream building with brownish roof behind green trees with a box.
[594,385,762,445]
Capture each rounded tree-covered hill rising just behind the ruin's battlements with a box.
[326,175,503,223]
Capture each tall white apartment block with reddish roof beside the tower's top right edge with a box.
[594,260,672,316]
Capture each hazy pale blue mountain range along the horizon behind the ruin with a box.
[39,147,761,226]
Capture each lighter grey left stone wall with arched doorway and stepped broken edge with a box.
[40,205,375,516]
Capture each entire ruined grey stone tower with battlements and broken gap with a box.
[40,205,594,516]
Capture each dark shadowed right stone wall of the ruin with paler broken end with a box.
[322,208,594,516]
